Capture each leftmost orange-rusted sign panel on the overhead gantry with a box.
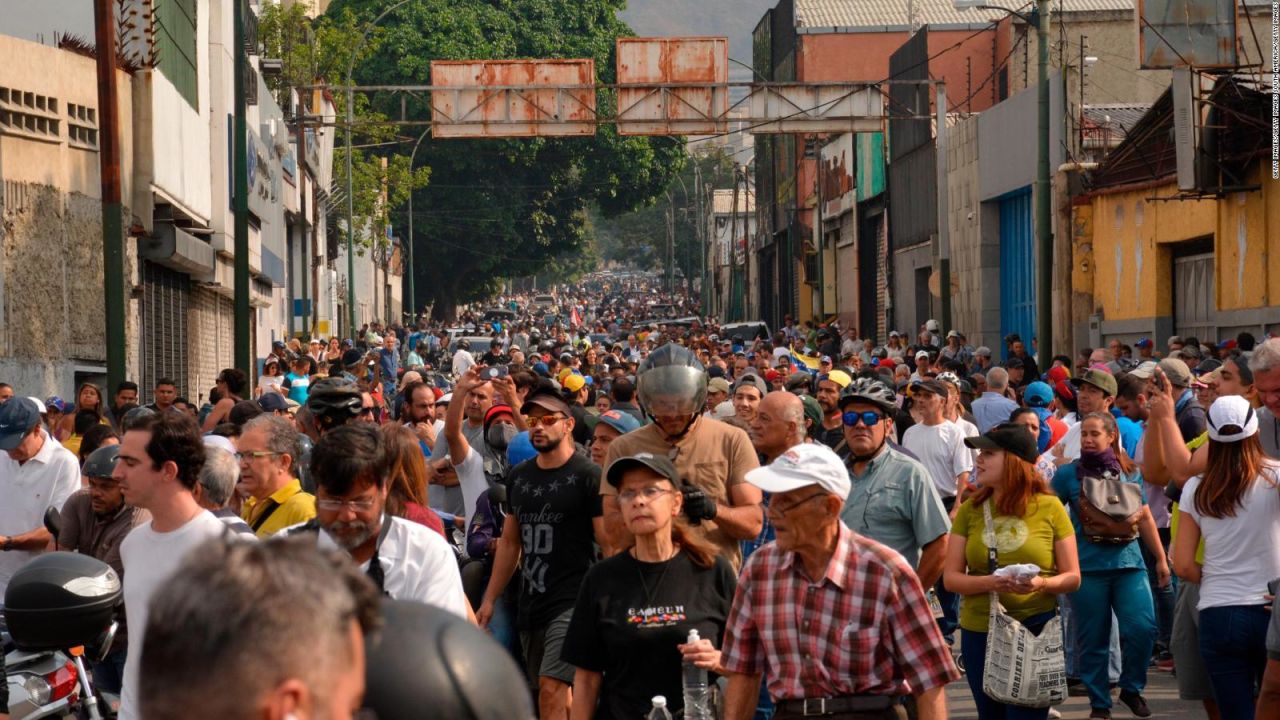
[431,59,596,138]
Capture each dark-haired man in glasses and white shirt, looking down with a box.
[296,423,468,618]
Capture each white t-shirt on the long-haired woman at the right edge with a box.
[1178,462,1280,610]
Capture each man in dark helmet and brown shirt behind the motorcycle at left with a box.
[58,445,151,693]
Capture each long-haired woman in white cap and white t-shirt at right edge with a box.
[1172,396,1280,720]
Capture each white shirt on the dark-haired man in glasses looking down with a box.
[316,509,468,619]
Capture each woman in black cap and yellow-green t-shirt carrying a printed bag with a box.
[942,414,1080,720]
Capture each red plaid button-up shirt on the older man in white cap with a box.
[722,523,960,700]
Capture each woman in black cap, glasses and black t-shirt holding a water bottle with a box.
[562,454,736,720]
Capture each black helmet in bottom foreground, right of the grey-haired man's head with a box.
[365,600,534,720]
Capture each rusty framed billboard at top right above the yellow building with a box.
[1137,0,1238,70]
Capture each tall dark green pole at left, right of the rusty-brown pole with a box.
[232,0,250,378]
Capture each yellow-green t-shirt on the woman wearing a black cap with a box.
[951,495,1075,633]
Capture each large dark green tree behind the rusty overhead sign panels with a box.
[329,0,685,318]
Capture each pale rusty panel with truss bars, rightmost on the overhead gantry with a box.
[748,82,884,135]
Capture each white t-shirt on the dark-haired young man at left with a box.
[119,510,227,720]
